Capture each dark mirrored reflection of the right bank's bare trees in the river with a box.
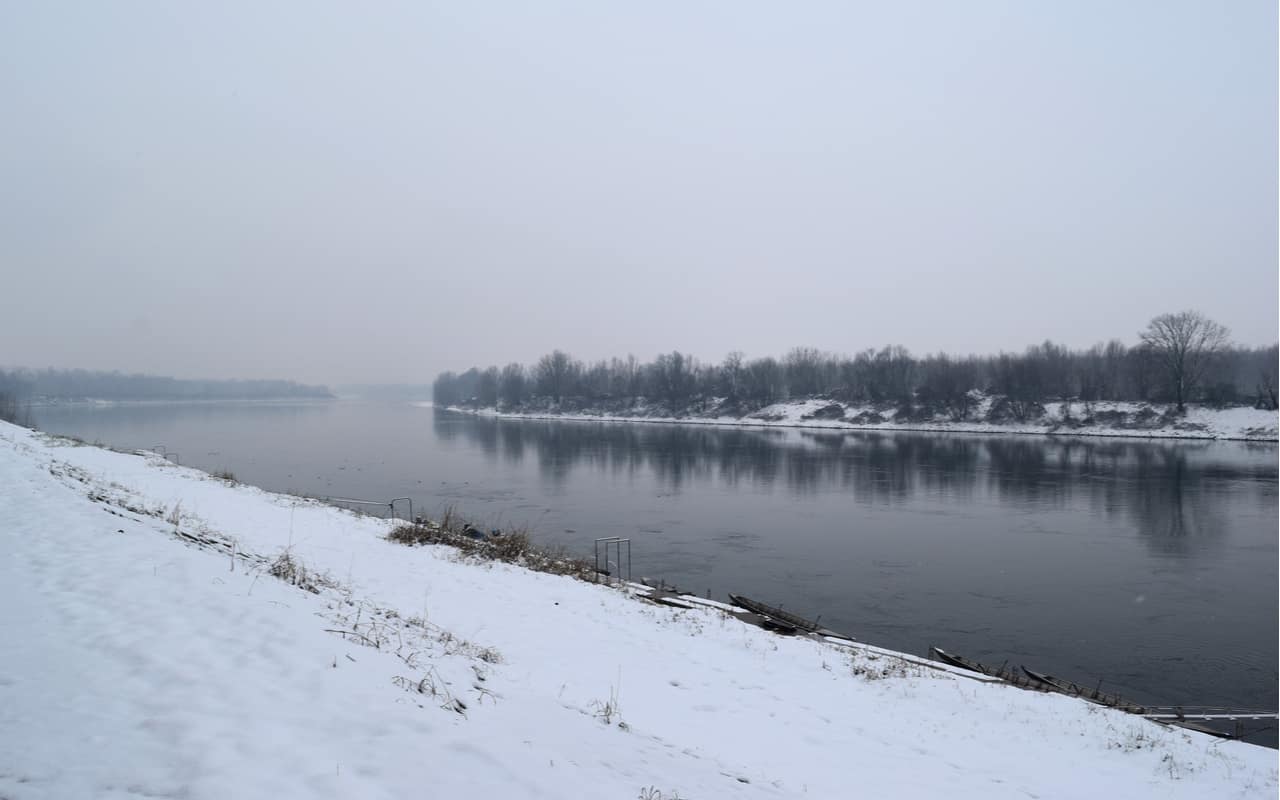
[436,412,1277,554]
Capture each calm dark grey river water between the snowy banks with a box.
[36,402,1277,740]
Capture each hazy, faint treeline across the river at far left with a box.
[0,369,333,403]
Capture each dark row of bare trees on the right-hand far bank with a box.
[433,311,1277,420]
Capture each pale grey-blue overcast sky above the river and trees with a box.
[0,0,1277,384]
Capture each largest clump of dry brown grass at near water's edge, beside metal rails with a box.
[387,508,595,581]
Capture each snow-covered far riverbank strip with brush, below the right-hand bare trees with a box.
[442,397,1280,442]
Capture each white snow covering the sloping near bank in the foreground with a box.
[0,424,1277,800]
